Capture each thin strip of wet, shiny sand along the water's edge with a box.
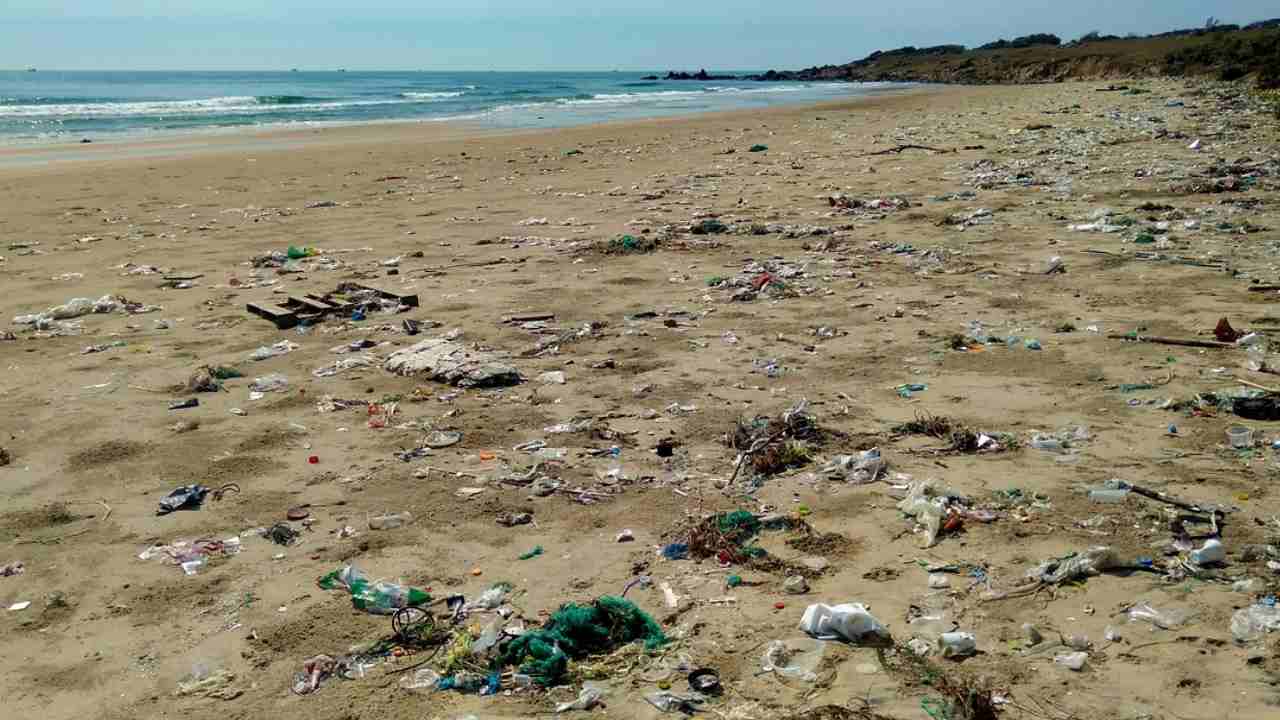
[0,83,926,173]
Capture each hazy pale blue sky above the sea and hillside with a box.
[0,0,1280,70]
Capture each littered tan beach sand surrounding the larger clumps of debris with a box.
[0,82,1280,720]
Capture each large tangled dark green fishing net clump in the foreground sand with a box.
[499,596,667,685]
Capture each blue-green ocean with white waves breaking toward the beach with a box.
[0,70,892,143]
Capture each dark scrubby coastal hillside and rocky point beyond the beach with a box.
[668,19,1280,88]
